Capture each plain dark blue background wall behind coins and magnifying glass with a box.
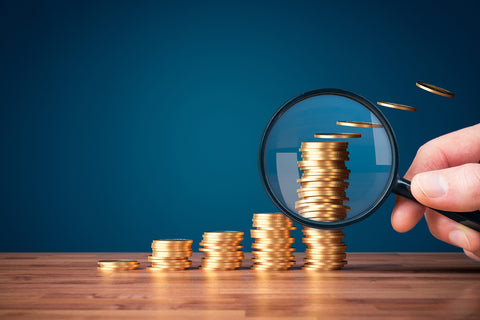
[0,0,480,251]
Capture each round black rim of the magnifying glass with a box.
[258,88,398,229]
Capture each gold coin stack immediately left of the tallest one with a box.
[250,213,296,270]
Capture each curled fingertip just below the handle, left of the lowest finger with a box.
[391,196,425,232]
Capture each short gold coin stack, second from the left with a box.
[147,239,193,271]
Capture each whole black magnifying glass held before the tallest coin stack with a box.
[258,89,480,231]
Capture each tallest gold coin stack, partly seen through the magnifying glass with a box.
[295,142,350,270]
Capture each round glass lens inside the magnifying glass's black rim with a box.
[261,94,396,225]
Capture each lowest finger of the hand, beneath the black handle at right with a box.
[425,209,480,255]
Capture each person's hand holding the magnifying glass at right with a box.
[392,124,480,261]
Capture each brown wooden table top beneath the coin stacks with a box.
[0,253,480,320]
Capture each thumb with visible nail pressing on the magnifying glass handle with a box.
[411,163,480,212]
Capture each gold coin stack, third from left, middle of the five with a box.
[199,231,244,270]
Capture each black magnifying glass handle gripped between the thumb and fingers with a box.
[392,177,480,232]
